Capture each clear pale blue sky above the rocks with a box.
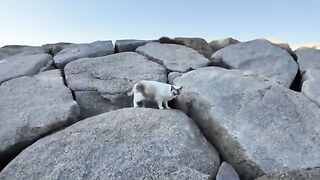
[0,0,320,47]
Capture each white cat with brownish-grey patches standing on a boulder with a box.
[128,80,182,109]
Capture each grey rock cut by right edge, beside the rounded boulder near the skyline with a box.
[295,48,320,74]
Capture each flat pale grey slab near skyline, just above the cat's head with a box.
[136,42,210,72]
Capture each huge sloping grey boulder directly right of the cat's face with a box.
[174,67,320,179]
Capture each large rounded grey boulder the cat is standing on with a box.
[0,108,220,180]
